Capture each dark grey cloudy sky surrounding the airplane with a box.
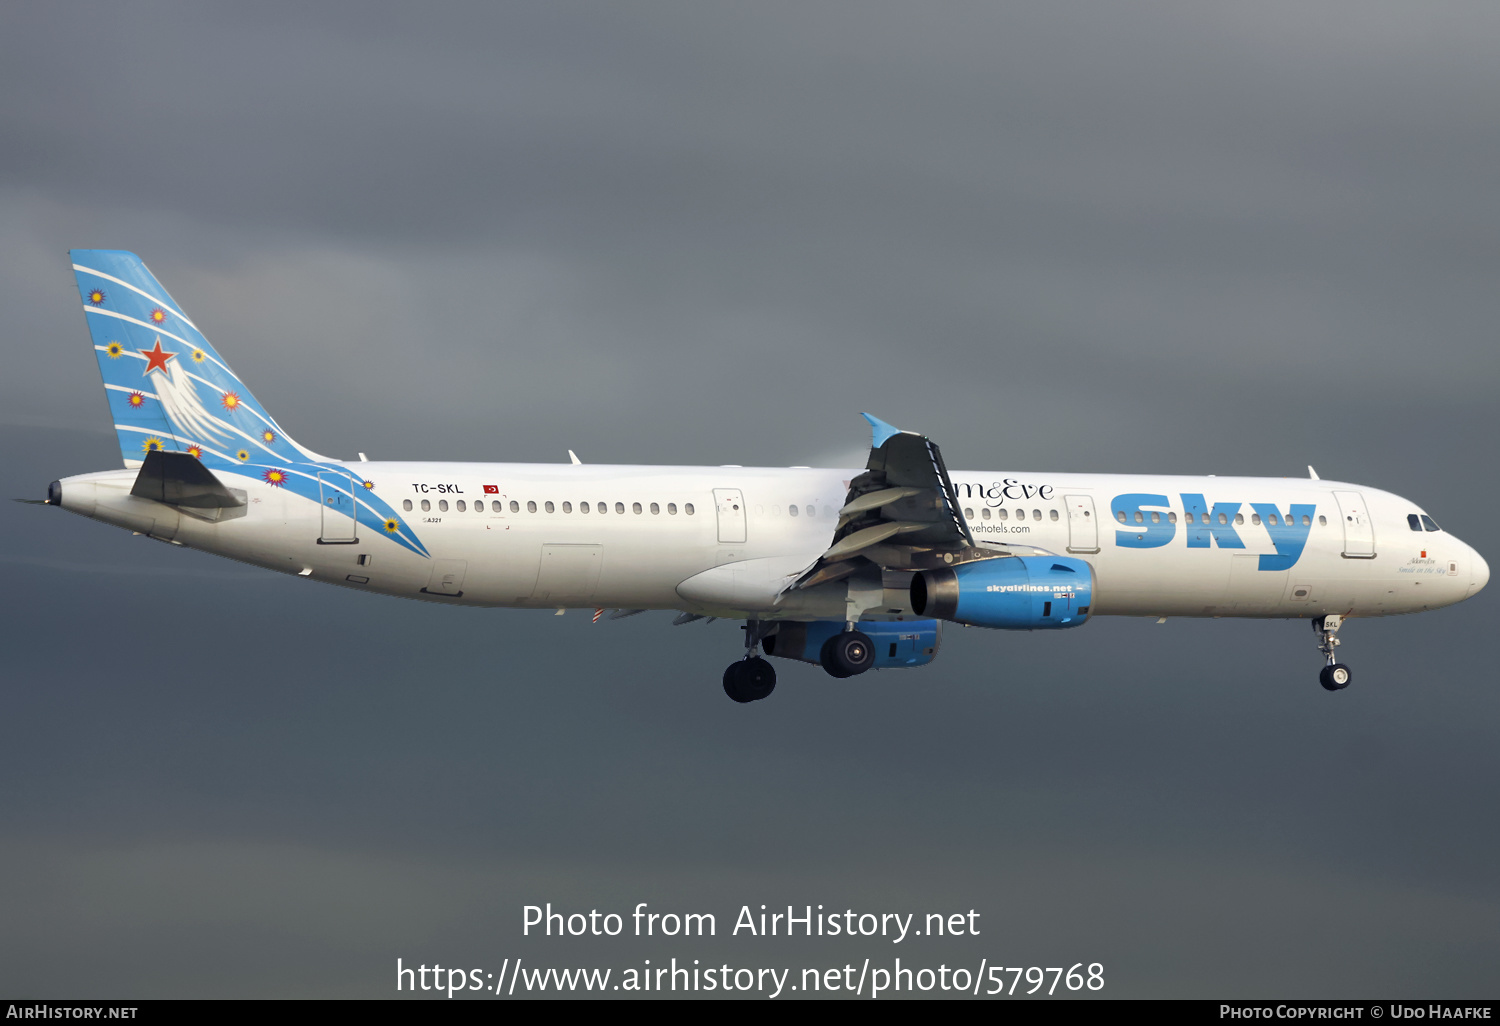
[0,3,1500,996]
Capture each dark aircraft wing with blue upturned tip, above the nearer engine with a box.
[792,414,977,588]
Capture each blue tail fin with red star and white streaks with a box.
[71,249,329,467]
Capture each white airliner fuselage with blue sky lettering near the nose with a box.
[62,462,1490,620]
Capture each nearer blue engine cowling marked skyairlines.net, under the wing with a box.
[912,557,1094,630]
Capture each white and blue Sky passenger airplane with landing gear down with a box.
[39,249,1490,704]
